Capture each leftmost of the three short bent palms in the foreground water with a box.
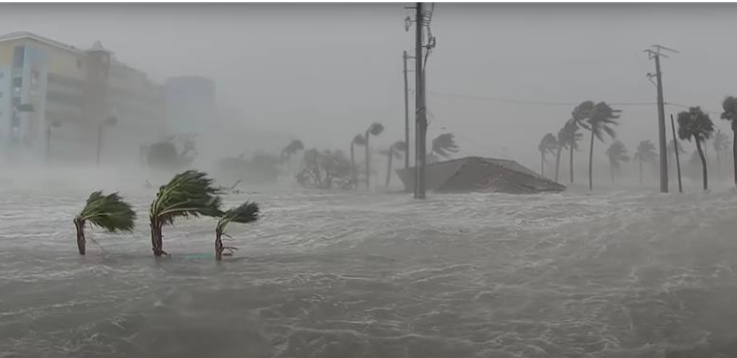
[73,191,136,255]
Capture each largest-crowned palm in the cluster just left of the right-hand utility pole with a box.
[573,101,622,190]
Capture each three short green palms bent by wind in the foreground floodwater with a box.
[73,170,259,261]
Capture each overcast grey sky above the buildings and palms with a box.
[0,4,737,168]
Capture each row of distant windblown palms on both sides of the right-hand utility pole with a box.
[538,96,737,190]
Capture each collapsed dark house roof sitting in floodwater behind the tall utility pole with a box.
[396,157,566,194]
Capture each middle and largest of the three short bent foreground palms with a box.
[148,170,222,257]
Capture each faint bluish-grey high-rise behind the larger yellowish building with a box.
[165,76,218,134]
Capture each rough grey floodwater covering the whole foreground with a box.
[0,183,737,358]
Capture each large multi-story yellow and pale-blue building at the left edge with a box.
[0,32,166,162]
